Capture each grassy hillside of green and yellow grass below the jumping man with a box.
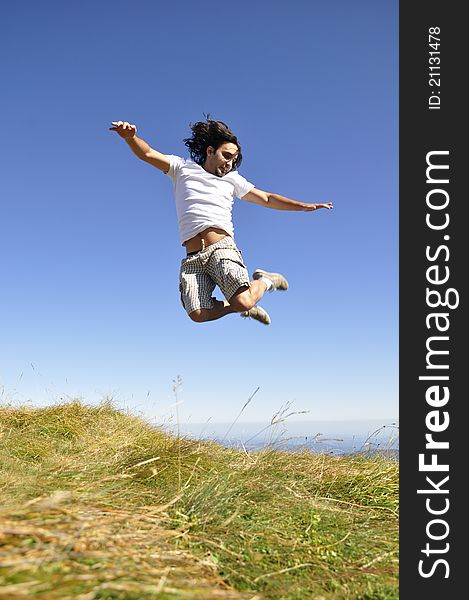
[0,402,398,600]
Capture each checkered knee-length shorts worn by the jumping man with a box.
[179,236,249,314]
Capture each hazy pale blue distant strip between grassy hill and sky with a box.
[166,419,399,457]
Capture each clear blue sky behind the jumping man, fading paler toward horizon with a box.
[0,0,398,422]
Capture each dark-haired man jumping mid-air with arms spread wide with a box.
[109,116,332,325]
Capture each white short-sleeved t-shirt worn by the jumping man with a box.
[167,154,254,244]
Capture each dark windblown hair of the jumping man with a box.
[183,115,243,170]
